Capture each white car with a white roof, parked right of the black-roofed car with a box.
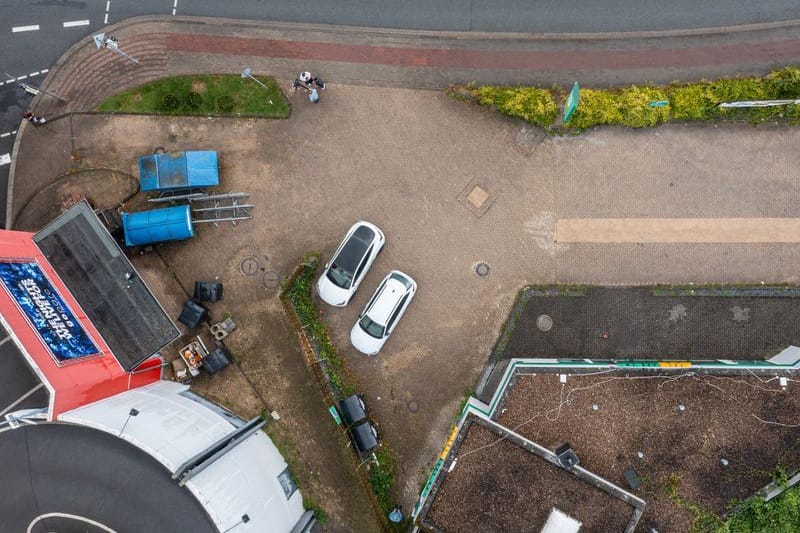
[350,270,417,355]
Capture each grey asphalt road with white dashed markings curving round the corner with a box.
[0,0,800,229]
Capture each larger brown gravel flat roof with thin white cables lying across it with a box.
[498,373,800,531]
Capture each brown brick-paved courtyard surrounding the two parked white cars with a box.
[10,81,800,516]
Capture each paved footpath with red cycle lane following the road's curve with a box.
[14,17,800,224]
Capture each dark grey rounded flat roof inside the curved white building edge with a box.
[0,424,216,533]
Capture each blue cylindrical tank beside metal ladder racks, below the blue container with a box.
[122,205,194,246]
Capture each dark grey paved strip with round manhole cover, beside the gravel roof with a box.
[503,287,800,359]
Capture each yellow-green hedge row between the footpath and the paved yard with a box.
[469,67,800,130]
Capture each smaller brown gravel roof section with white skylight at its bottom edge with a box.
[427,424,633,533]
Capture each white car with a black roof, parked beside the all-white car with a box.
[317,220,386,307]
